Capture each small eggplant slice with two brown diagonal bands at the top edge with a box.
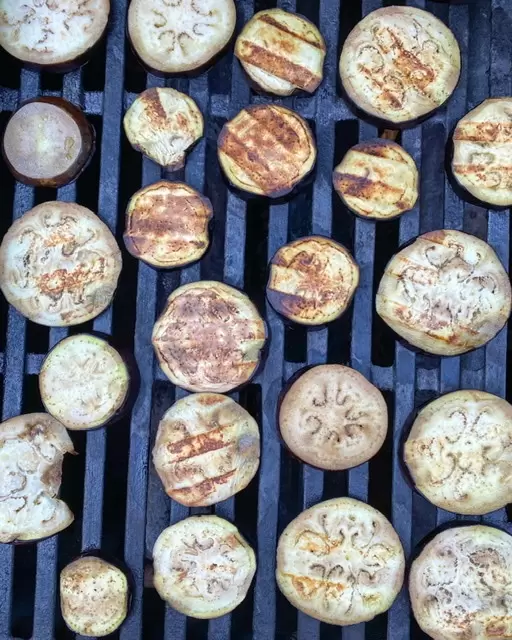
[235,9,326,96]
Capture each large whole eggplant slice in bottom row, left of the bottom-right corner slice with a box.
[276,498,405,626]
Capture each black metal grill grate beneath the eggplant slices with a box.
[0,0,512,640]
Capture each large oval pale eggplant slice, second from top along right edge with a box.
[376,229,511,356]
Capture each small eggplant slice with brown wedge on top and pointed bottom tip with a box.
[123,88,204,171]
